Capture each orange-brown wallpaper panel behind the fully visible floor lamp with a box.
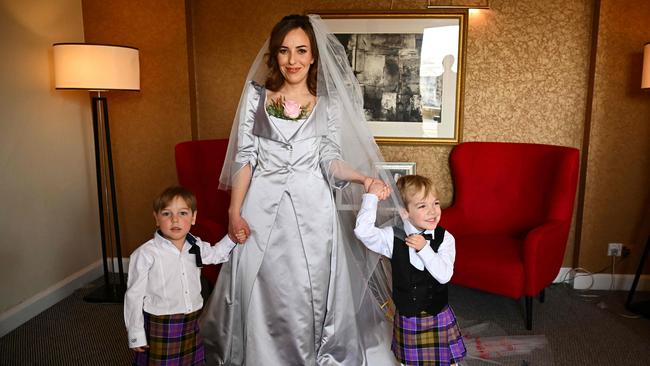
[83,0,191,256]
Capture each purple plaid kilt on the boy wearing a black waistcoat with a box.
[391,306,467,365]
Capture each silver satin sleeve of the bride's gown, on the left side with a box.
[231,82,264,176]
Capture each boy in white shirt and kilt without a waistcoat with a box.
[124,186,236,365]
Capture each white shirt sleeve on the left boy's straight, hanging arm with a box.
[124,248,153,348]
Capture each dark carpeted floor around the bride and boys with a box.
[0,285,650,366]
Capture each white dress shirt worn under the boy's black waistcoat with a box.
[354,193,456,283]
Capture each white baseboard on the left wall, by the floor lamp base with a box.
[0,260,103,337]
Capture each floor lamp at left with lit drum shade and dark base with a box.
[53,43,140,303]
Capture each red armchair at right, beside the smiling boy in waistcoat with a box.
[441,142,579,330]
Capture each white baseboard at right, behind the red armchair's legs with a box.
[553,267,650,291]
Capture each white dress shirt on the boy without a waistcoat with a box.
[124,232,236,348]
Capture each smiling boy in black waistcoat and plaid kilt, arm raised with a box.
[354,175,466,365]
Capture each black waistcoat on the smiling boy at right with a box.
[390,225,448,316]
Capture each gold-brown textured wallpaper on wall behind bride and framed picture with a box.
[193,0,592,263]
